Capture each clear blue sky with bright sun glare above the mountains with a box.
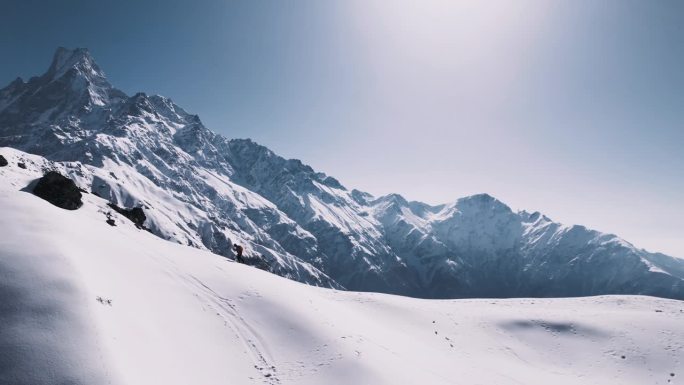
[0,0,684,257]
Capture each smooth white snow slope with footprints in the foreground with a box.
[0,149,684,385]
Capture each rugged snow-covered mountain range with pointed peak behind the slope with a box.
[0,48,684,299]
